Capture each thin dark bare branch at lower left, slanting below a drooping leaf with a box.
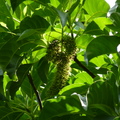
[27,73,42,110]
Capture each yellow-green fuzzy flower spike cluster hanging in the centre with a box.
[46,36,76,98]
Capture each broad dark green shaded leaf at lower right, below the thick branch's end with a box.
[87,81,114,108]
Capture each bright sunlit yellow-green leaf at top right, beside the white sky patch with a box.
[84,0,110,18]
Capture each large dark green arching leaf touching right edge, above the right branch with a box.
[85,36,120,62]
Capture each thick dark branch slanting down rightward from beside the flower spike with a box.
[74,56,96,78]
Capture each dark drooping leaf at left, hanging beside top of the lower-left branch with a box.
[7,64,32,99]
